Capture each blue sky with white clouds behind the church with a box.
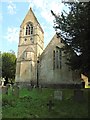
[0,0,69,54]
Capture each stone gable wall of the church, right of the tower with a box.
[39,35,80,84]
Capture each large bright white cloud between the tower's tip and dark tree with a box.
[27,0,64,23]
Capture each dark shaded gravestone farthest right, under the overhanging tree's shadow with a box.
[73,89,84,102]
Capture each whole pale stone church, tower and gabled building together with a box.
[15,8,79,86]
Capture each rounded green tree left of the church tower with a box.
[2,53,16,79]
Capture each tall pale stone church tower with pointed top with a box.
[15,8,44,83]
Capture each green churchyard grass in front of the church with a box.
[2,88,88,118]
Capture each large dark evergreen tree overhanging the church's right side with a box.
[51,2,90,76]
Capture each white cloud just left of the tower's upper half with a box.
[5,27,19,43]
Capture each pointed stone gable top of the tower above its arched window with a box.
[21,7,44,33]
